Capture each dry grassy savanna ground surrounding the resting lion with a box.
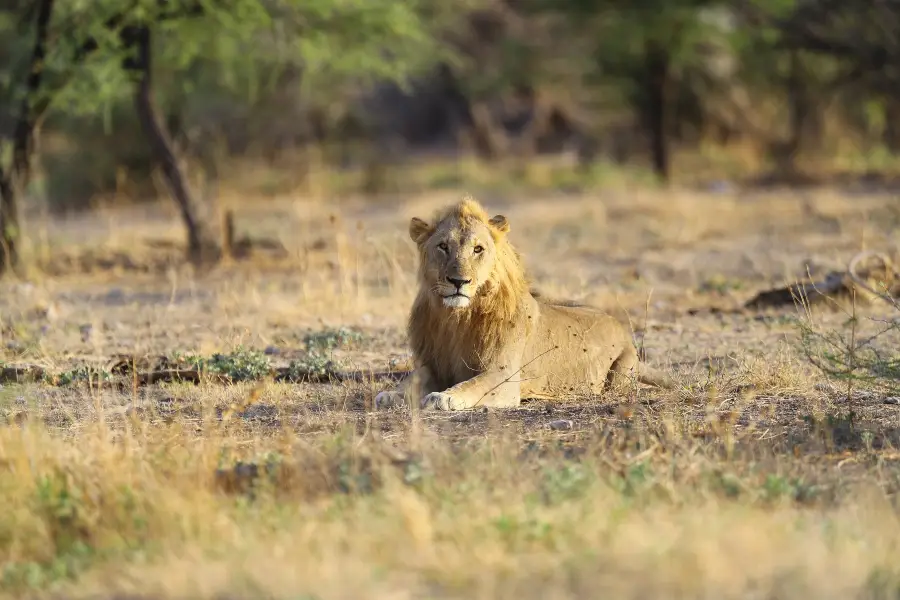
[0,170,900,600]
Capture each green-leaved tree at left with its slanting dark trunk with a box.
[0,0,452,268]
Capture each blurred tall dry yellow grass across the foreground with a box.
[0,408,900,599]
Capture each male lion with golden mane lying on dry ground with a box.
[375,196,673,410]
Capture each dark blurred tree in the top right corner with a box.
[739,0,900,167]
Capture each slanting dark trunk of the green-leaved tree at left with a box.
[123,26,223,265]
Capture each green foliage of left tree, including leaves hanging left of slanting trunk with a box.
[0,0,468,209]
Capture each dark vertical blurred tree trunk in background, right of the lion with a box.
[644,42,670,183]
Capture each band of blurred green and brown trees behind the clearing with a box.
[0,0,900,268]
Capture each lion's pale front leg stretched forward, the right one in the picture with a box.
[421,369,522,410]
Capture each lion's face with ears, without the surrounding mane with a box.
[409,210,509,309]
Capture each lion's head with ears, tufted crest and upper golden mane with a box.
[409,196,524,311]
